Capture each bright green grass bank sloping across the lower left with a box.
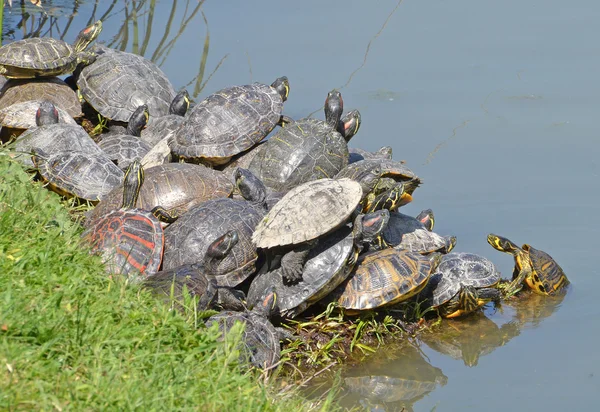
[0,151,332,411]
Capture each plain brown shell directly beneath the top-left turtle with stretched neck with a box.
[0,77,83,118]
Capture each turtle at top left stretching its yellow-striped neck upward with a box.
[0,20,102,79]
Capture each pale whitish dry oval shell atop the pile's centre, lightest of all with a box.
[252,179,362,248]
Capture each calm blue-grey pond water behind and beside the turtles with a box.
[4,0,600,411]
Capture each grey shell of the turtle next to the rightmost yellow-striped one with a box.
[431,252,500,307]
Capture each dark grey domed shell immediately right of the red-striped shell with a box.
[163,199,262,287]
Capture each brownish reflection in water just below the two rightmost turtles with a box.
[421,313,521,367]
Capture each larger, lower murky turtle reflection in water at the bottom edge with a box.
[342,344,448,410]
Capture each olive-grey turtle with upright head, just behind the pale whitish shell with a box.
[248,90,359,192]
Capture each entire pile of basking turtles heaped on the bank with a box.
[0,21,568,367]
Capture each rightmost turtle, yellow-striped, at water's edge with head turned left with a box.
[487,233,569,296]
